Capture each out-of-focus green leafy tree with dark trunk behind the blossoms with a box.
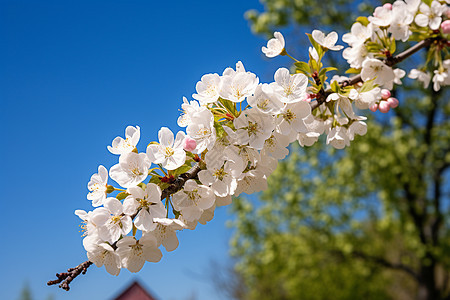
[231,0,450,300]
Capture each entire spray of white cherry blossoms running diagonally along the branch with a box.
[70,0,450,275]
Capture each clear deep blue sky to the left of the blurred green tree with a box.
[0,0,294,300]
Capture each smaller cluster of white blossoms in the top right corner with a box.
[342,0,450,91]
